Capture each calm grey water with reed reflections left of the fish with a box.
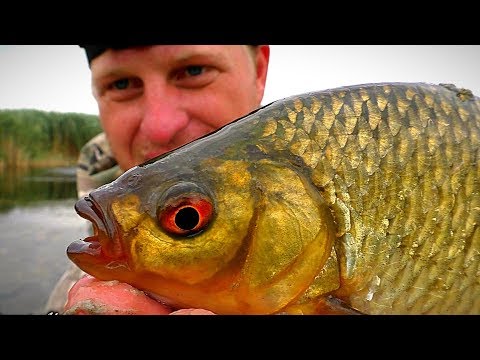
[0,168,89,314]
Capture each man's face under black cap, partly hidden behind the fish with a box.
[91,45,269,170]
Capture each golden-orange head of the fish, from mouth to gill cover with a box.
[67,109,338,314]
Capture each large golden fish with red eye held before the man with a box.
[67,83,480,314]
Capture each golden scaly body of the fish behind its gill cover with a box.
[259,84,480,314]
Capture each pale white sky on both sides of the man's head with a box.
[0,45,480,115]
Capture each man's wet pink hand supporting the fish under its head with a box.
[63,275,214,315]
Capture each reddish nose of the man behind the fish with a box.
[140,90,188,144]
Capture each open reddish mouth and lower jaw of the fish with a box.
[67,196,131,280]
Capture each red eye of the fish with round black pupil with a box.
[158,195,213,235]
